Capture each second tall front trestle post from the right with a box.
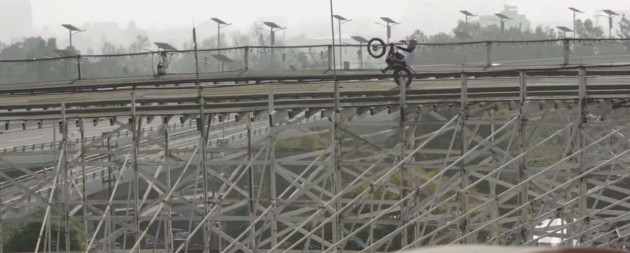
[517,72,534,244]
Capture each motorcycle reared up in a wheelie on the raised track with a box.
[368,38,416,87]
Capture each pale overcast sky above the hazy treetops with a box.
[31,0,630,40]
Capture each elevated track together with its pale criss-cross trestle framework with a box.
[0,63,630,251]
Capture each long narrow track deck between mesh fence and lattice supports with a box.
[0,70,630,121]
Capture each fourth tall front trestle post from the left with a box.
[267,82,278,248]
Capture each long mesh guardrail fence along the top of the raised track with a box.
[0,38,630,84]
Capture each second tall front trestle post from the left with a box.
[131,90,142,253]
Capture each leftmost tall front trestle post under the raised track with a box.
[57,101,71,253]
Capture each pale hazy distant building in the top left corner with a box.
[0,0,33,43]
